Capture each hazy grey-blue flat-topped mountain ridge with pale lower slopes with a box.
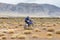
[0,3,60,17]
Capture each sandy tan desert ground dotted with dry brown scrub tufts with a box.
[0,17,60,40]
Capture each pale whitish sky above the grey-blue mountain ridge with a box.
[0,0,60,7]
